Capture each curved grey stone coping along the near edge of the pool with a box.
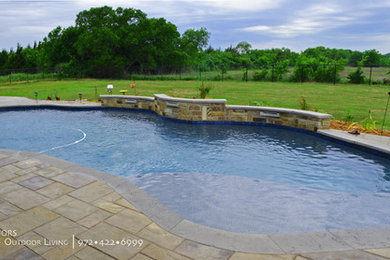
[0,149,390,254]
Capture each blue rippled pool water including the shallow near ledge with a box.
[0,110,390,233]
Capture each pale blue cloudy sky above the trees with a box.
[0,0,390,54]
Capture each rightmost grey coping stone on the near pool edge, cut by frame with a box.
[330,227,390,249]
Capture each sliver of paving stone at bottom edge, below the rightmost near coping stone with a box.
[302,250,384,260]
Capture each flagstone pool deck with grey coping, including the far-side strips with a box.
[0,97,390,259]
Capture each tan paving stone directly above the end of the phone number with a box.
[105,209,152,233]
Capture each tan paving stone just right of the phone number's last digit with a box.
[137,223,184,250]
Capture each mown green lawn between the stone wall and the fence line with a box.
[0,79,390,130]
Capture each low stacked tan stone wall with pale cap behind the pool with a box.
[100,94,332,131]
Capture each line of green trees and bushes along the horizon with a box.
[0,6,390,82]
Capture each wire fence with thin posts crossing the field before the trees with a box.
[0,64,390,85]
